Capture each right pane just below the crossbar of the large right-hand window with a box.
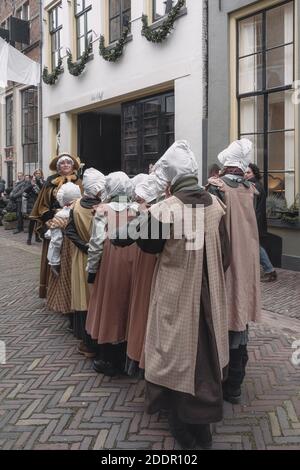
[268,90,295,131]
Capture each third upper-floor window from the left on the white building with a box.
[109,0,131,43]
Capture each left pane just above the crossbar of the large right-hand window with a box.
[239,54,262,94]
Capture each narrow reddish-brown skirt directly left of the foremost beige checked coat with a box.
[127,250,157,369]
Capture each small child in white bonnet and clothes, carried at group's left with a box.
[45,183,81,276]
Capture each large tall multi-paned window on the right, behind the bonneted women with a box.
[237,1,295,205]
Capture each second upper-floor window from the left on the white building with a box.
[75,0,92,59]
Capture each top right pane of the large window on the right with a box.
[267,2,294,49]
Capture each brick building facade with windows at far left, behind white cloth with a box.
[0,0,41,186]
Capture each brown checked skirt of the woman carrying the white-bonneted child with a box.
[47,236,73,313]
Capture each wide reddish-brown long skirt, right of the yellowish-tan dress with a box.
[86,239,138,344]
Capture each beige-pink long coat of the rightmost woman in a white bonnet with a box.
[210,179,261,331]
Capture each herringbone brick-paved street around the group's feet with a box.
[0,227,300,449]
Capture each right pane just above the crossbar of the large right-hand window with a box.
[267,45,294,88]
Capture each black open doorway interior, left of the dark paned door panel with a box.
[78,110,121,174]
